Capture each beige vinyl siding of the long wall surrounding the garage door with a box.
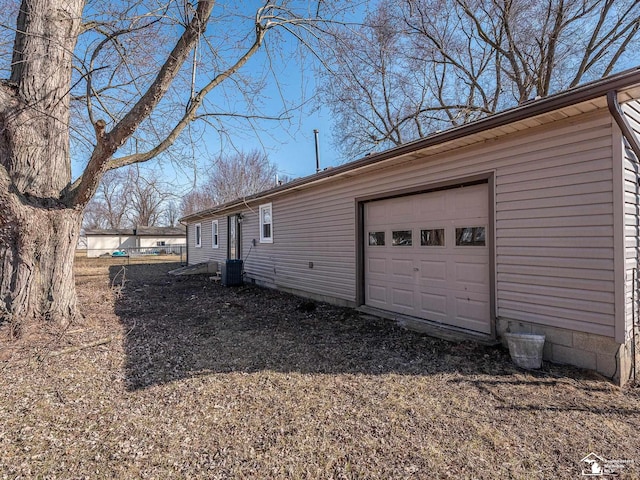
[189,111,616,336]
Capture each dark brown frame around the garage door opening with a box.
[355,171,496,338]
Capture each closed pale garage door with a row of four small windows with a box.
[364,184,491,334]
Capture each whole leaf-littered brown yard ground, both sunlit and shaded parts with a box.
[0,257,640,479]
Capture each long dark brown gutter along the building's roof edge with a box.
[180,67,640,223]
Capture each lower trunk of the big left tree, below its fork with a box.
[0,197,82,337]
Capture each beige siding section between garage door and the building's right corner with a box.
[496,117,615,336]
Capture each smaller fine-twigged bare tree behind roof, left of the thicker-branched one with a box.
[320,2,428,157]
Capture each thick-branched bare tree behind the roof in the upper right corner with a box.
[448,0,640,102]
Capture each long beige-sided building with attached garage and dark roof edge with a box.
[181,68,640,383]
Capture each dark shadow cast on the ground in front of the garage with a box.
[109,264,604,390]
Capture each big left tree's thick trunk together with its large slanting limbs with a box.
[0,0,216,333]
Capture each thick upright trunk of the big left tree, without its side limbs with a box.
[0,0,84,335]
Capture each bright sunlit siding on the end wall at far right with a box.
[618,100,640,342]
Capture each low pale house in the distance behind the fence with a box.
[85,226,186,257]
